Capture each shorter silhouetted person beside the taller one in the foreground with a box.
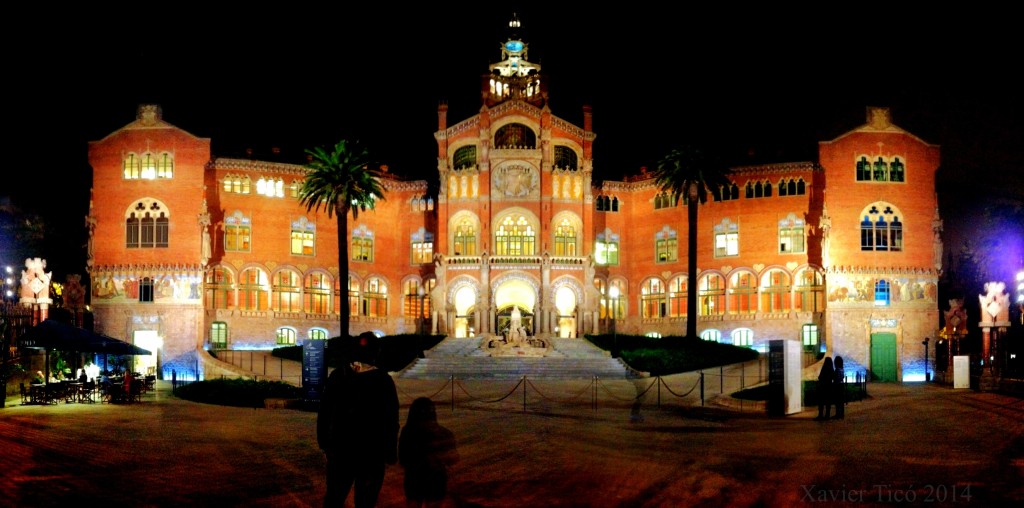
[398,397,459,508]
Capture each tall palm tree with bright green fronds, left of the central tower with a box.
[299,139,384,337]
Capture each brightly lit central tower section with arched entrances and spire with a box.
[431,16,596,337]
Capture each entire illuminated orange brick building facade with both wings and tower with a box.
[87,29,941,379]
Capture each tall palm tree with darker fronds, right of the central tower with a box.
[653,146,729,338]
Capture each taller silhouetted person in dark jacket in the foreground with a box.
[316,333,398,508]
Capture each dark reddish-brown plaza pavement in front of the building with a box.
[0,375,1024,508]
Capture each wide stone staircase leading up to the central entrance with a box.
[398,337,644,379]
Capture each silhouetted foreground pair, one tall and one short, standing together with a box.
[316,333,459,508]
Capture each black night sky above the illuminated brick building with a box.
[0,2,1024,280]
